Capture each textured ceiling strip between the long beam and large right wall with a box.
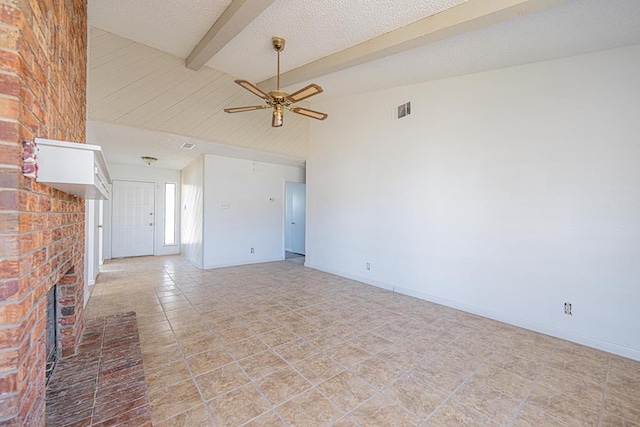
[302,0,640,98]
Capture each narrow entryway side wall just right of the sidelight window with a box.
[180,156,204,268]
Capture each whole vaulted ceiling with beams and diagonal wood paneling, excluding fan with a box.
[88,0,640,169]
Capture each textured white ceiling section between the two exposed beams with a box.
[207,0,467,82]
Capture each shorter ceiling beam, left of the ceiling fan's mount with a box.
[186,0,274,71]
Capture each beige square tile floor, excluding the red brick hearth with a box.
[86,256,640,427]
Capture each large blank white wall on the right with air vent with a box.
[306,46,640,359]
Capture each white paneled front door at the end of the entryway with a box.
[111,180,156,258]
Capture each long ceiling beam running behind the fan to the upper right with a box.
[258,0,567,90]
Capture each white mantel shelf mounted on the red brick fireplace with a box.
[35,138,111,200]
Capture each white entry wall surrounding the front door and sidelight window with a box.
[104,164,180,259]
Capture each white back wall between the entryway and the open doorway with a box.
[204,155,305,268]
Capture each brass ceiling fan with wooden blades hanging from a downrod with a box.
[224,37,327,127]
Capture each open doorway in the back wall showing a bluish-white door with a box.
[284,182,307,263]
